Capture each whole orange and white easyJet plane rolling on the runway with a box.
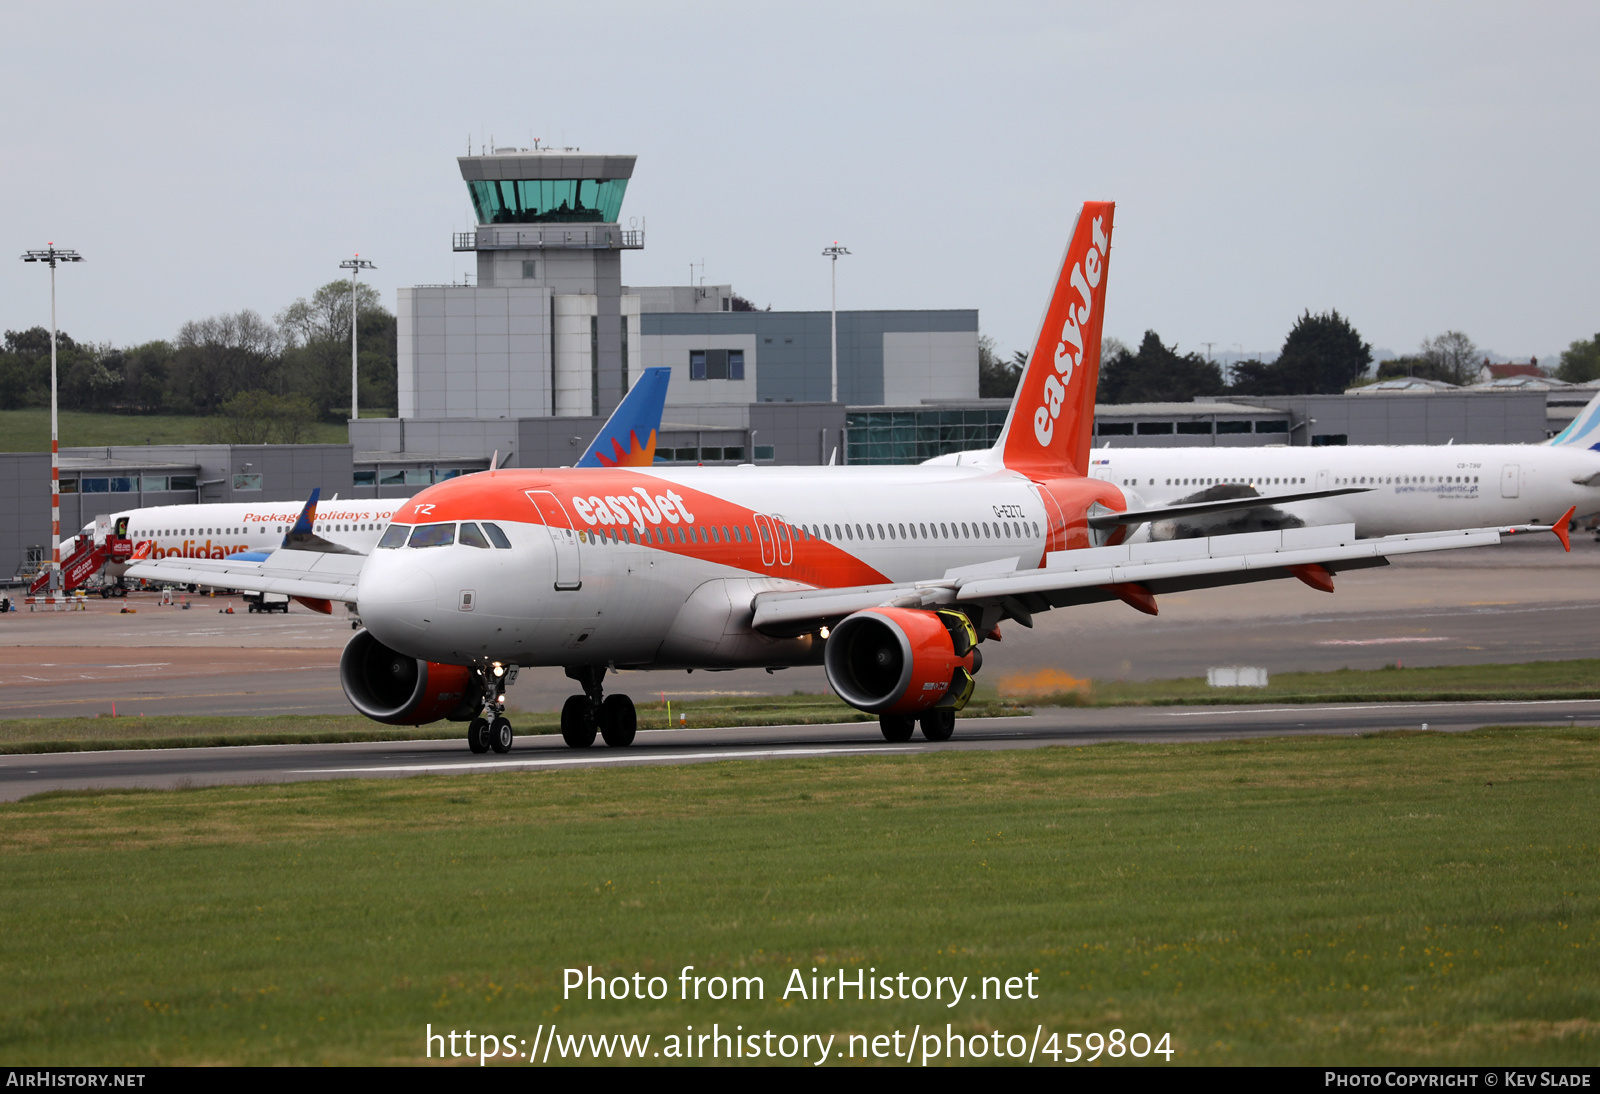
[128,202,1565,752]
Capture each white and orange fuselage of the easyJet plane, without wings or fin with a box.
[357,465,1125,667]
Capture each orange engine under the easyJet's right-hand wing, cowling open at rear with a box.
[822,608,982,715]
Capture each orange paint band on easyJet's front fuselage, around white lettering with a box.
[394,469,890,589]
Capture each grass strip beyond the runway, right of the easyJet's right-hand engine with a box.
[1000,661,1600,707]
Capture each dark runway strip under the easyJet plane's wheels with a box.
[0,699,1600,801]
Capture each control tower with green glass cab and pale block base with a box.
[397,149,645,417]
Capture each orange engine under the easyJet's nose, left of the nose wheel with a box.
[339,630,483,726]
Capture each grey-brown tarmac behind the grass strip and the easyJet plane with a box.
[0,536,1600,718]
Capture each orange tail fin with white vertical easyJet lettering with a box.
[995,202,1117,478]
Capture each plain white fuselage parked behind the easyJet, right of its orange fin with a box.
[1090,445,1600,537]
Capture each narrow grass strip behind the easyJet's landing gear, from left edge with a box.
[0,694,1026,755]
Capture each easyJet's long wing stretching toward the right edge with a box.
[752,521,1565,635]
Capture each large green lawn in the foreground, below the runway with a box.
[0,729,1600,1065]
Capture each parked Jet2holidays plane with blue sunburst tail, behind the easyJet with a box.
[79,368,672,588]
